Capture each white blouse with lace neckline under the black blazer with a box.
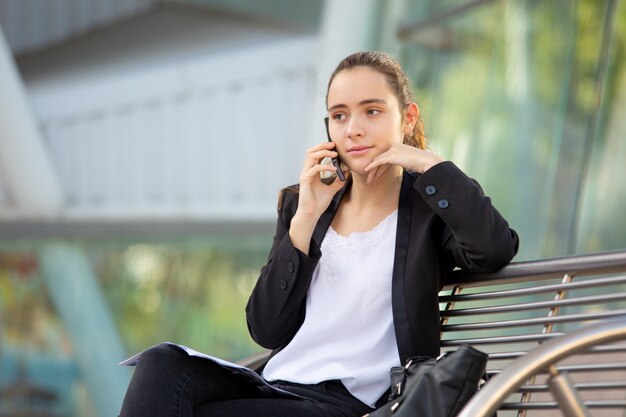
[263,210,400,406]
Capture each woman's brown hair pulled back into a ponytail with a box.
[326,51,426,149]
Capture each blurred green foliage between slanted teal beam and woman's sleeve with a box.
[91,237,271,360]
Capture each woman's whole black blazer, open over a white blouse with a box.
[246,162,518,363]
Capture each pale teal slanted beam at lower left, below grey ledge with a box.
[39,243,130,417]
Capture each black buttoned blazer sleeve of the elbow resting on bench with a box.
[413,161,519,272]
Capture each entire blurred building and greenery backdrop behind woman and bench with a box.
[0,0,626,417]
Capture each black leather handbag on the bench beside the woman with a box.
[364,345,487,417]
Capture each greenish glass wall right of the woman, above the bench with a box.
[398,0,626,260]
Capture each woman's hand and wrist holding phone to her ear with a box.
[289,142,344,254]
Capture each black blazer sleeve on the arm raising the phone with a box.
[246,190,321,349]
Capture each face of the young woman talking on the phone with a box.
[327,66,404,174]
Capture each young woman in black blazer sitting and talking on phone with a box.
[121,52,518,417]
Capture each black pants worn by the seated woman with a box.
[120,344,371,417]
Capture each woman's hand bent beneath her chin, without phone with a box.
[365,143,444,184]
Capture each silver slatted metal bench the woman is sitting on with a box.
[242,251,626,417]
